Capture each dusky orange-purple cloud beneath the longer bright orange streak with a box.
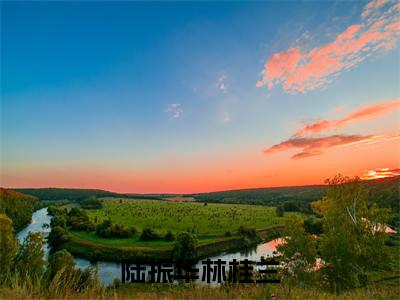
[264,135,378,159]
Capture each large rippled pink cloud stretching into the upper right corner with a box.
[256,0,400,94]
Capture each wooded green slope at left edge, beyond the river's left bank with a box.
[0,188,38,231]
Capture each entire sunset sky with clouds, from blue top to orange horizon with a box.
[0,0,400,193]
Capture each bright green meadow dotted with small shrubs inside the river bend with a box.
[87,198,285,238]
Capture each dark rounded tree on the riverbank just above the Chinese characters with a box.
[173,232,198,263]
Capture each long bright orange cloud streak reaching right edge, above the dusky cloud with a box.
[296,98,400,136]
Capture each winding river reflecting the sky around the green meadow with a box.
[17,208,279,285]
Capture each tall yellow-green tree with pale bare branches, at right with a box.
[312,175,390,292]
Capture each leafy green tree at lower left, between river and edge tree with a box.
[15,232,46,282]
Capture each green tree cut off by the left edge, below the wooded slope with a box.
[0,214,18,284]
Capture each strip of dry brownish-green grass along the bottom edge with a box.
[0,284,400,300]
